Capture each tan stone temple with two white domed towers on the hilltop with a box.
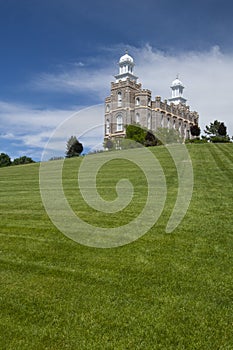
[105,52,199,144]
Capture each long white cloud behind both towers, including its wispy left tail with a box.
[31,45,233,135]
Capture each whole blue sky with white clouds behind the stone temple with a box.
[0,0,233,160]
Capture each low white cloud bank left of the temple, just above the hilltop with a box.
[0,102,104,159]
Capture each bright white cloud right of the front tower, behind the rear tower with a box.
[133,46,233,135]
